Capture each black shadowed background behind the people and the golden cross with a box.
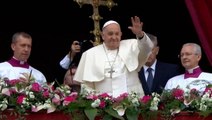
[0,0,211,83]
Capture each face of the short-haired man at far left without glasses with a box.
[11,35,32,61]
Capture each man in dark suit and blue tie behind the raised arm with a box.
[139,33,180,95]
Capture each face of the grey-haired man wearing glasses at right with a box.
[180,44,201,70]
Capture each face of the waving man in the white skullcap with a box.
[102,23,122,50]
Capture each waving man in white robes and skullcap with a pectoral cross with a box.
[74,16,153,97]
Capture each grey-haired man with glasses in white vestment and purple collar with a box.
[165,43,212,92]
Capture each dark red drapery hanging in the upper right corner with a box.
[185,0,212,65]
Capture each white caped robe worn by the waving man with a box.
[74,34,153,97]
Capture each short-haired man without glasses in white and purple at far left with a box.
[0,32,46,85]
